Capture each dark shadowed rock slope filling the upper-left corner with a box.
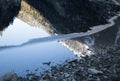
[0,0,21,31]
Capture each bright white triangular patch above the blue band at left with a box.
[0,18,50,46]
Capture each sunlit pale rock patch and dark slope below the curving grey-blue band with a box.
[60,18,120,56]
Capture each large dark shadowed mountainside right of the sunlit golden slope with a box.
[24,0,120,34]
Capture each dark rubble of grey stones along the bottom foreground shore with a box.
[0,47,120,81]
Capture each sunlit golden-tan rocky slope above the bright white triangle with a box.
[17,1,55,35]
